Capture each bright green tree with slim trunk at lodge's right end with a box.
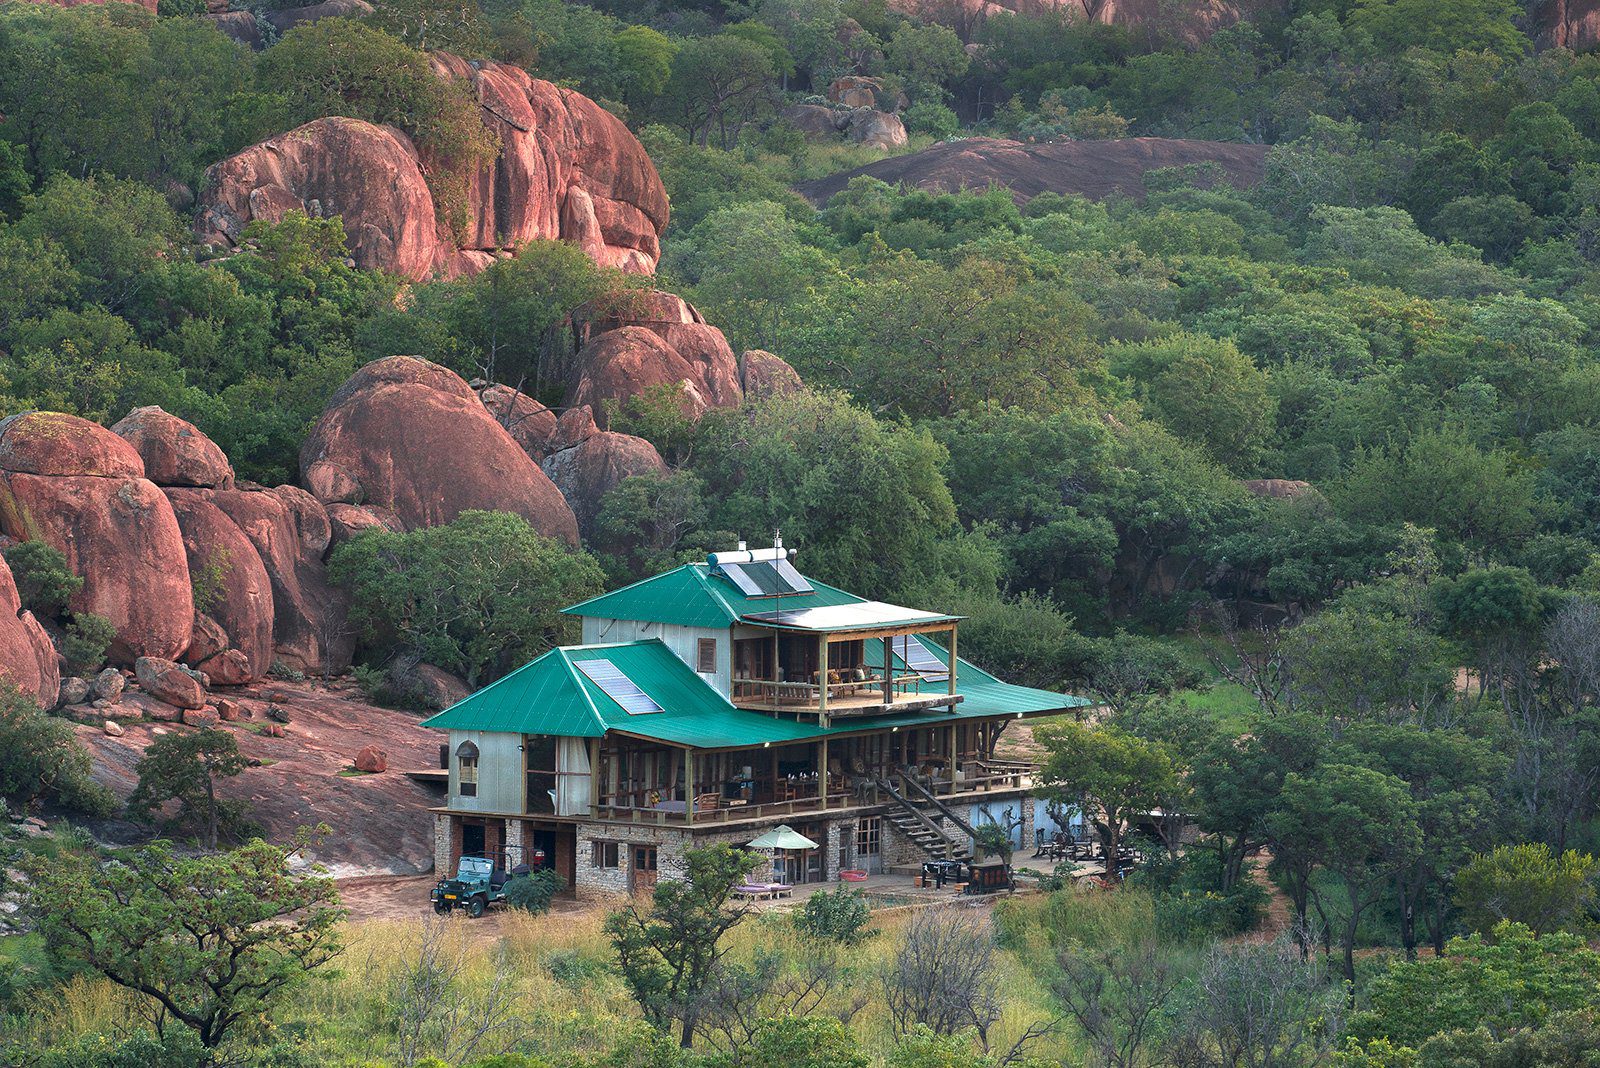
[1035,723,1181,881]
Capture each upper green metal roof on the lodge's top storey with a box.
[562,564,866,628]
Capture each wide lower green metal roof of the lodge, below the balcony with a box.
[422,638,1091,748]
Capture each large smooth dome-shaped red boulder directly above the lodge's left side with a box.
[301,357,578,545]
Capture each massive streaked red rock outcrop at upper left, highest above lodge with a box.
[197,53,667,280]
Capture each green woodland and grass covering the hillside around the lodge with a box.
[0,0,1600,1068]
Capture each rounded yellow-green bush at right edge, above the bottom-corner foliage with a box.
[1456,843,1600,935]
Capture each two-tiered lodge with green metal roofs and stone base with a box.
[424,545,1090,897]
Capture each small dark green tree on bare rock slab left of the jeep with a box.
[128,729,253,849]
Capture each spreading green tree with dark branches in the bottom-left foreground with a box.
[22,839,344,1063]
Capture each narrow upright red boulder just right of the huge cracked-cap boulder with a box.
[166,488,275,684]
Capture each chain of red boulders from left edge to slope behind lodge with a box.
[0,293,798,707]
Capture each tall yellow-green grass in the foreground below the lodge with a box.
[0,895,1106,1068]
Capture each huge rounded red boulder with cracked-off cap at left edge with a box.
[0,412,194,664]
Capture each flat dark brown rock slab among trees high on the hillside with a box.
[797,137,1267,205]
